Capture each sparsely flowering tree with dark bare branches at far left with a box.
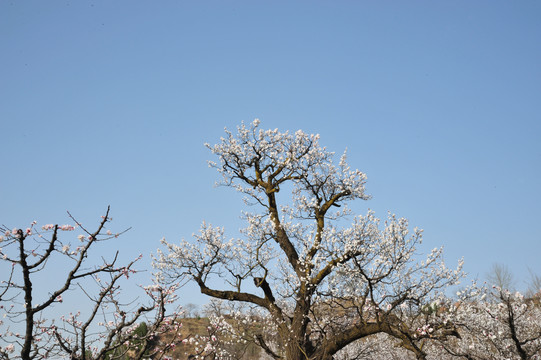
[0,209,182,360]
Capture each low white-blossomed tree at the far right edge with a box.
[435,285,541,360]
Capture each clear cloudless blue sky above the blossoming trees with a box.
[0,0,541,303]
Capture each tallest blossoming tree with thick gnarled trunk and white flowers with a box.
[155,119,462,360]
